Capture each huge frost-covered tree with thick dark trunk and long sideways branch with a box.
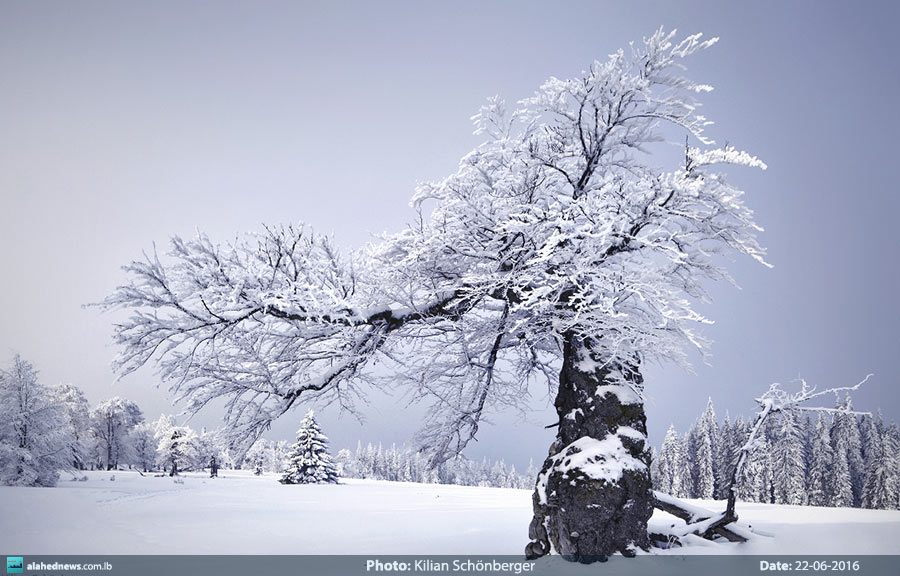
[104,30,764,559]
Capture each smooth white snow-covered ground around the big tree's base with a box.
[0,471,900,555]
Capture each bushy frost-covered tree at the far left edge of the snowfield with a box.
[0,354,73,486]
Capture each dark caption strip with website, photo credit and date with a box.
[6,555,900,576]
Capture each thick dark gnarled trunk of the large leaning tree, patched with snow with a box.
[525,337,653,562]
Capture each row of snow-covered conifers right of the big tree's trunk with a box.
[652,397,900,509]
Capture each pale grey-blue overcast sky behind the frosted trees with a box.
[0,0,900,466]
